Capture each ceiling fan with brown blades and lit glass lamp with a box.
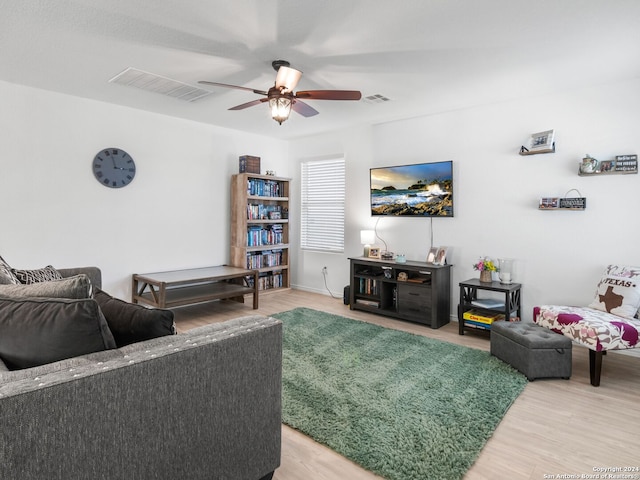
[198,60,362,125]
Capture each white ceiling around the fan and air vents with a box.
[0,0,640,139]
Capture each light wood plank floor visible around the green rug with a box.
[175,290,640,480]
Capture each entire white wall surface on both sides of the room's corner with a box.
[5,80,640,315]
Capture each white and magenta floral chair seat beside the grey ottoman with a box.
[533,305,640,352]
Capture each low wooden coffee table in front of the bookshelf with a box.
[131,265,258,309]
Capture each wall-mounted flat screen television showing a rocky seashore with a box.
[370,161,453,217]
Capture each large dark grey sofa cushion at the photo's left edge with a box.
[0,297,116,370]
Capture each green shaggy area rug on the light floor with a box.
[273,308,527,480]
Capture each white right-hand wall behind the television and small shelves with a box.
[290,80,640,318]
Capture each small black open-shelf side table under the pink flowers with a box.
[458,278,522,335]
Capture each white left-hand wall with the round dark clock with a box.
[0,83,288,299]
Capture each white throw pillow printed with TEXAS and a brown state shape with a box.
[589,265,640,318]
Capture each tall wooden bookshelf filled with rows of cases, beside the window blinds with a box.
[231,173,291,292]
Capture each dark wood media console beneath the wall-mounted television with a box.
[349,257,451,328]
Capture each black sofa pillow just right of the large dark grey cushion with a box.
[94,288,176,347]
